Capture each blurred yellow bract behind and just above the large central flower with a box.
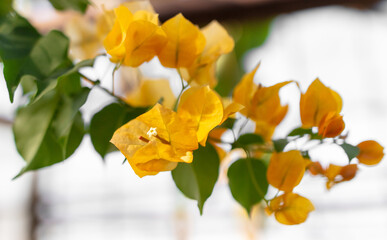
[125,79,176,108]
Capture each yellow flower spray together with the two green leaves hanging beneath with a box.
[104,3,384,225]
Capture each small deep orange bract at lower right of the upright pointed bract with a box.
[318,112,345,138]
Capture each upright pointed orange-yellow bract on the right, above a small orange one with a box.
[300,78,343,128]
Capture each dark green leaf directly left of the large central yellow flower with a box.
[89,103,147,158]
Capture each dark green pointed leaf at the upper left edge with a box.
[0,13,40,102]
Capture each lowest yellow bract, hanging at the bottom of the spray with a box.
[266,192,314,225]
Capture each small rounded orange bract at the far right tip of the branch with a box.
[357,140,384,165]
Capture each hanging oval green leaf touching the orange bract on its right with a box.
[227,158,269,213]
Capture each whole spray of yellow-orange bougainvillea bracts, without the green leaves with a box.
[100,2,384,224]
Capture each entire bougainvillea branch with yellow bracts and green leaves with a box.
[0,0,384,225]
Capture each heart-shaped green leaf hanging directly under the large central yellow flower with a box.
[172,143,220,214]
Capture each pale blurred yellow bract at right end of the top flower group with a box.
[185,21,234,88]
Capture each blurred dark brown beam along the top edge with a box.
[151,0,381,25]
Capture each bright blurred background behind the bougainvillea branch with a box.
[0,0,387,240]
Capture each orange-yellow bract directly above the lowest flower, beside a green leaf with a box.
[267,150,305,192]
